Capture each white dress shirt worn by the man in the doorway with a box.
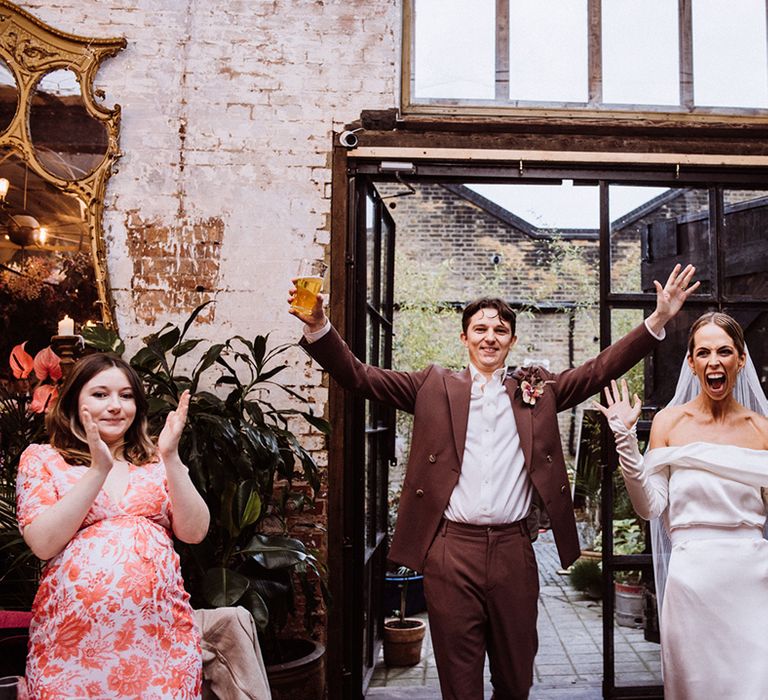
[445,363,533,525]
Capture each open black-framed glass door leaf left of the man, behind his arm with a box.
[344,178,395,691]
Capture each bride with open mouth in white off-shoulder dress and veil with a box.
[595,312,768,700]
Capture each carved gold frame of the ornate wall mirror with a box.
[0,0,127,328]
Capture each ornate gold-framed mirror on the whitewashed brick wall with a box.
[0,1,126,370]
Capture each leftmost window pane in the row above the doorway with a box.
[414,0,496,99]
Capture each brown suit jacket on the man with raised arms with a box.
[301,324,658,571]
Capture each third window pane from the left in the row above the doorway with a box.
[602,0,680,105]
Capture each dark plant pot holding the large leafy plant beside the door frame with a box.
[267,639,325,700]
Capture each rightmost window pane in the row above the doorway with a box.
[693,0,768,107]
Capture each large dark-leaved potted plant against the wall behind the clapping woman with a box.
[83,304,329,698]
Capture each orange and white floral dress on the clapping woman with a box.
[17,445,202,700]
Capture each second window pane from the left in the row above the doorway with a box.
[509,0,589,102]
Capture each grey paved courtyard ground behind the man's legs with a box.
[366,533,661,700]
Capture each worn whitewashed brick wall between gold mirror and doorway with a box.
[19,0,401,652]
